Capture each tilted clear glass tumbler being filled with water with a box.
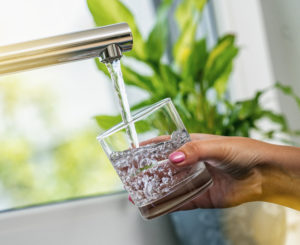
[97,99,212,219]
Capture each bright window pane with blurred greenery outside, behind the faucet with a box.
[0,0,153,210]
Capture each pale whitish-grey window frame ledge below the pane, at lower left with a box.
[0,193,178,245]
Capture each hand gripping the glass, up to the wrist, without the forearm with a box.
[169,134,270,210]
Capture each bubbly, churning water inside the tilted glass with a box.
[110,130,203,206]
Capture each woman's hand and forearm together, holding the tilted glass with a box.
[169,134,300,210]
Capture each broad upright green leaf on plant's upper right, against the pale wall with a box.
[204,35,238,89]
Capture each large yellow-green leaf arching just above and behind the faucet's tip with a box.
[87,0,146,59]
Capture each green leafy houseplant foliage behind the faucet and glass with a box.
[87,0,299,140]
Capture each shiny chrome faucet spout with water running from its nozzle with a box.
[0,23,133,75]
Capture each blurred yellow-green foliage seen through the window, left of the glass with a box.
[0,79,121,209]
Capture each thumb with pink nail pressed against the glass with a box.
[169,139,227,166]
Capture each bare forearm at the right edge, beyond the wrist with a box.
[259,145,300,210]
